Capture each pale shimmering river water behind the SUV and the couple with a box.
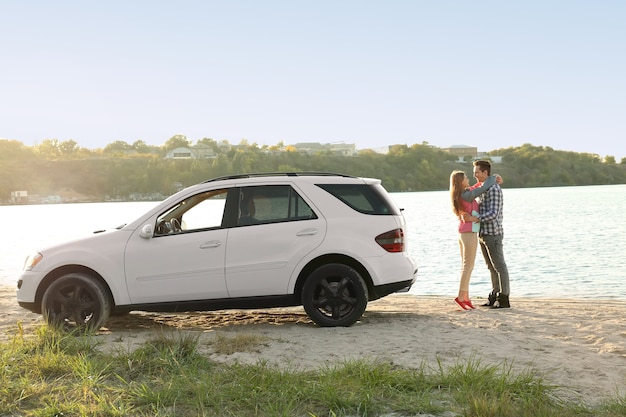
[0,185,626,300]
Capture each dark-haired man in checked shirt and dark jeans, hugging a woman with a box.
[474,160,511,308]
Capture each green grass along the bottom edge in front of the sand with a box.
[0,327,626,417]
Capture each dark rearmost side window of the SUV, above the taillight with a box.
[317,184,400,216]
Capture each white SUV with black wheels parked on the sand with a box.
[17,173,417,329]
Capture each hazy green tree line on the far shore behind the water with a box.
[0,135,626,202]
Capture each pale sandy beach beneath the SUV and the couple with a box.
[0,287,626,404]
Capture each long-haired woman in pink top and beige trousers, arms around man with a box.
[450,170,502,310]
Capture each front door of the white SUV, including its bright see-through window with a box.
[125,190,228,304]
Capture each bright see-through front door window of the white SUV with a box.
[155,189,228,236]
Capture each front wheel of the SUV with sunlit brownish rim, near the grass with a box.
[42,273,112,330]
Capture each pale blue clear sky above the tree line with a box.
[0,0,626,161]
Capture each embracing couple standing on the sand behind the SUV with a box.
[450,160,511,310]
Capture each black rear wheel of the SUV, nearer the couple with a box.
[302,264,368,327]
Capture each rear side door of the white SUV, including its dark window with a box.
[225,185,326,297]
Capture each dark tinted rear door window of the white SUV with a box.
[237,185,317,226]
